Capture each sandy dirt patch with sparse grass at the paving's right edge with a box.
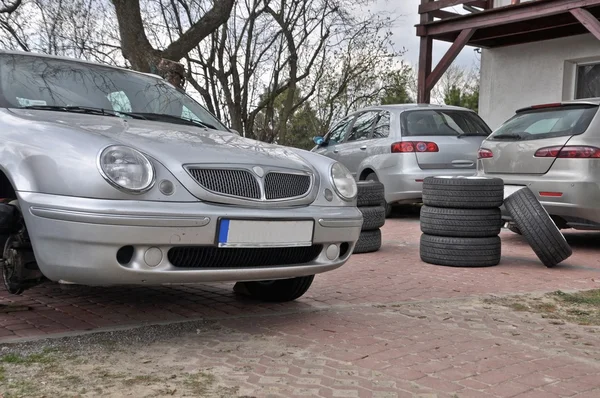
[485,289,600,326]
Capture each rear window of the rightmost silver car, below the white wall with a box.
[489,105,598,140]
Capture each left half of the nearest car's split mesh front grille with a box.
[189,169,260,199]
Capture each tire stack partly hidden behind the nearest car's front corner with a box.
[353,181,385,254]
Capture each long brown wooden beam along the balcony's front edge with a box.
[417,0,600,36]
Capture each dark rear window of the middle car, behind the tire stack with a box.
[400,109,491,137]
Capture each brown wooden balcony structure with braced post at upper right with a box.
[416,0,600,103]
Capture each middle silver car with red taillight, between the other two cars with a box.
[313,104,491,213]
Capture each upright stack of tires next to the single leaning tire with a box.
[420,177,504,267]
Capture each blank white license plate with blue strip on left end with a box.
[218,219,314,247]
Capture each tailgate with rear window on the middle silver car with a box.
[400,108,491,174]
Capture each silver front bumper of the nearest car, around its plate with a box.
[17,192,362,285]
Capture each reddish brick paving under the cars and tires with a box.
[0,211,600,398]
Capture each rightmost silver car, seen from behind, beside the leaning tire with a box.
[478,99,600,233]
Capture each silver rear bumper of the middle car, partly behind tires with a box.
[377,166,476,204]
